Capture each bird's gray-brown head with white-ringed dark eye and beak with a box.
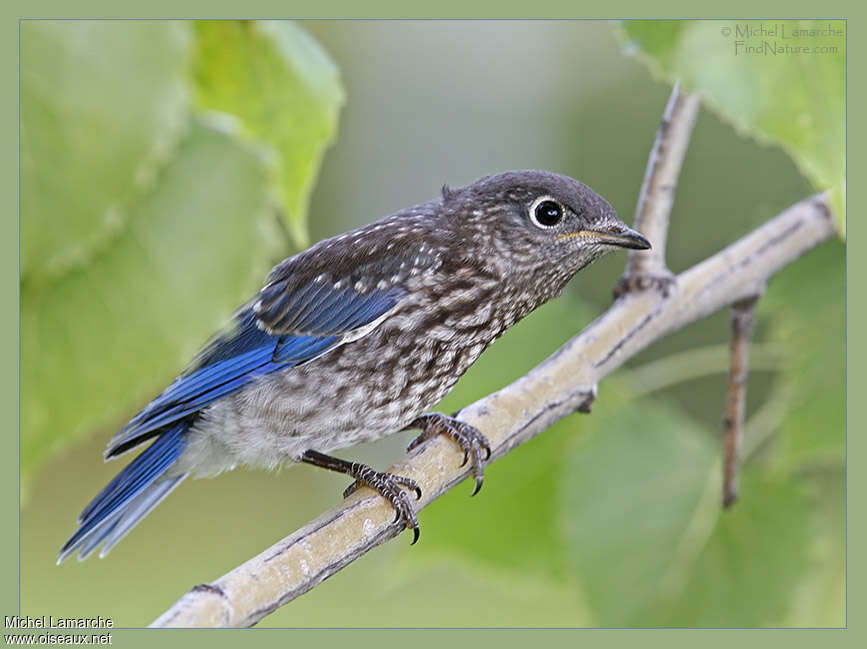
[443,170,650,286]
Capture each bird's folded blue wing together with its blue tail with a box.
[58,280,403,563]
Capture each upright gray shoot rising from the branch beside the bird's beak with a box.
[615,84,700,295]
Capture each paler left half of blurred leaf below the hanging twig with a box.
[560,393,719,626]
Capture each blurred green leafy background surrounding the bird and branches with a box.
[21,21,845,627]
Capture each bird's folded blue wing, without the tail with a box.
[106,280,404,458]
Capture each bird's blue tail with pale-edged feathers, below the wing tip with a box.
[57,419,192,564]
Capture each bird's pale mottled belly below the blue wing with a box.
[195,324,496,468]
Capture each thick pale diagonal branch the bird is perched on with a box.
[153,196,834,627]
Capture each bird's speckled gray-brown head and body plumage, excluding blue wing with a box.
[176,172,636,475]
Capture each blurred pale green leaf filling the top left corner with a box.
[21,21,191,279]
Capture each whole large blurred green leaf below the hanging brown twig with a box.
[562,400,810,626]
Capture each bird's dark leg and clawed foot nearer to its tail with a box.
[301,451,421,544]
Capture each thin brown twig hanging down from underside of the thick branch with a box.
[723,295,759,507]
